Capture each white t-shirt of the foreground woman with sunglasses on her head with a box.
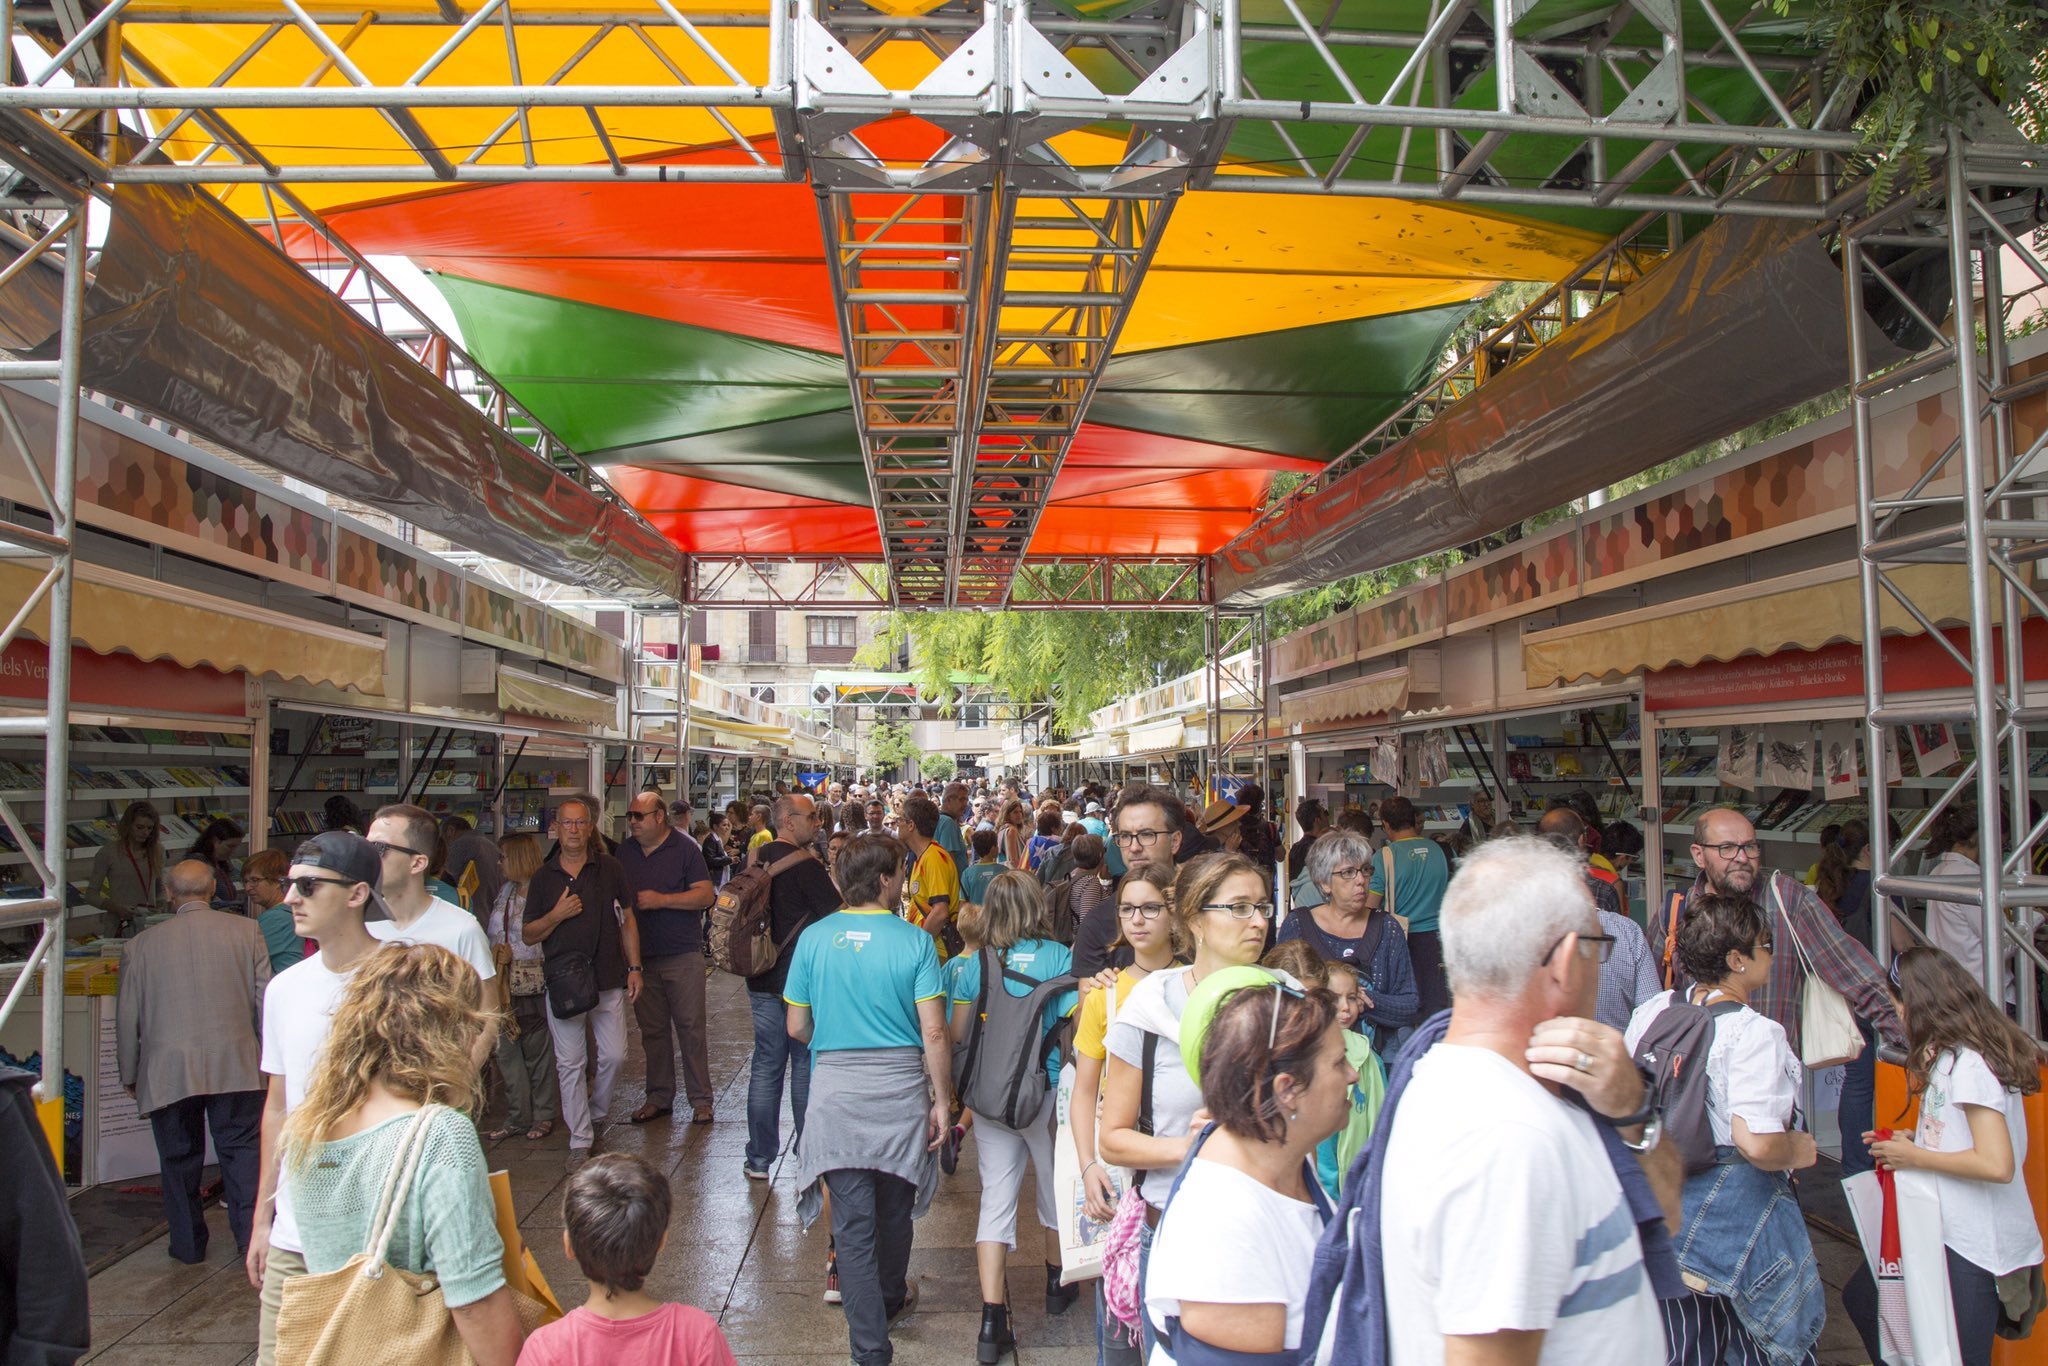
[1145,1149,1323,1366]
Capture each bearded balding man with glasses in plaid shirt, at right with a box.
[1649,809,1907,1055]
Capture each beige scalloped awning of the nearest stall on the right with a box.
[1522,565,1970,688]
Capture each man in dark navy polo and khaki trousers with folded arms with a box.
[618,793,717,1124]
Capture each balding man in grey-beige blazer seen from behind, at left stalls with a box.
[115,858,270,1262]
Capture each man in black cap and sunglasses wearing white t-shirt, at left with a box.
[246,829,389,1366]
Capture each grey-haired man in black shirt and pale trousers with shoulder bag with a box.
[520,797,641,1171]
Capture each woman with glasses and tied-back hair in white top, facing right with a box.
[1098,854,1274,1356]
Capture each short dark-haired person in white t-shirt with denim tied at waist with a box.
[1602,893,1825,1366]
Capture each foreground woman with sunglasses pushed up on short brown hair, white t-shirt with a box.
[1145,971,1358,1366]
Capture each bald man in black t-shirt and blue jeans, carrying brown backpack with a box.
[745,793,840,1182]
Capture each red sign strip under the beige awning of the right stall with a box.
[1642,621,2048,711]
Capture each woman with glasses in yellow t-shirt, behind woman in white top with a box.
[1067,864,1180,1366]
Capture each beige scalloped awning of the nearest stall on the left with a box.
[0,561,385,696]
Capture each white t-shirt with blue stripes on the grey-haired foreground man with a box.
[1376,1042,1665,1366]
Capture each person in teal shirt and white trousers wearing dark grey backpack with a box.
[952,872,1079,1364]
